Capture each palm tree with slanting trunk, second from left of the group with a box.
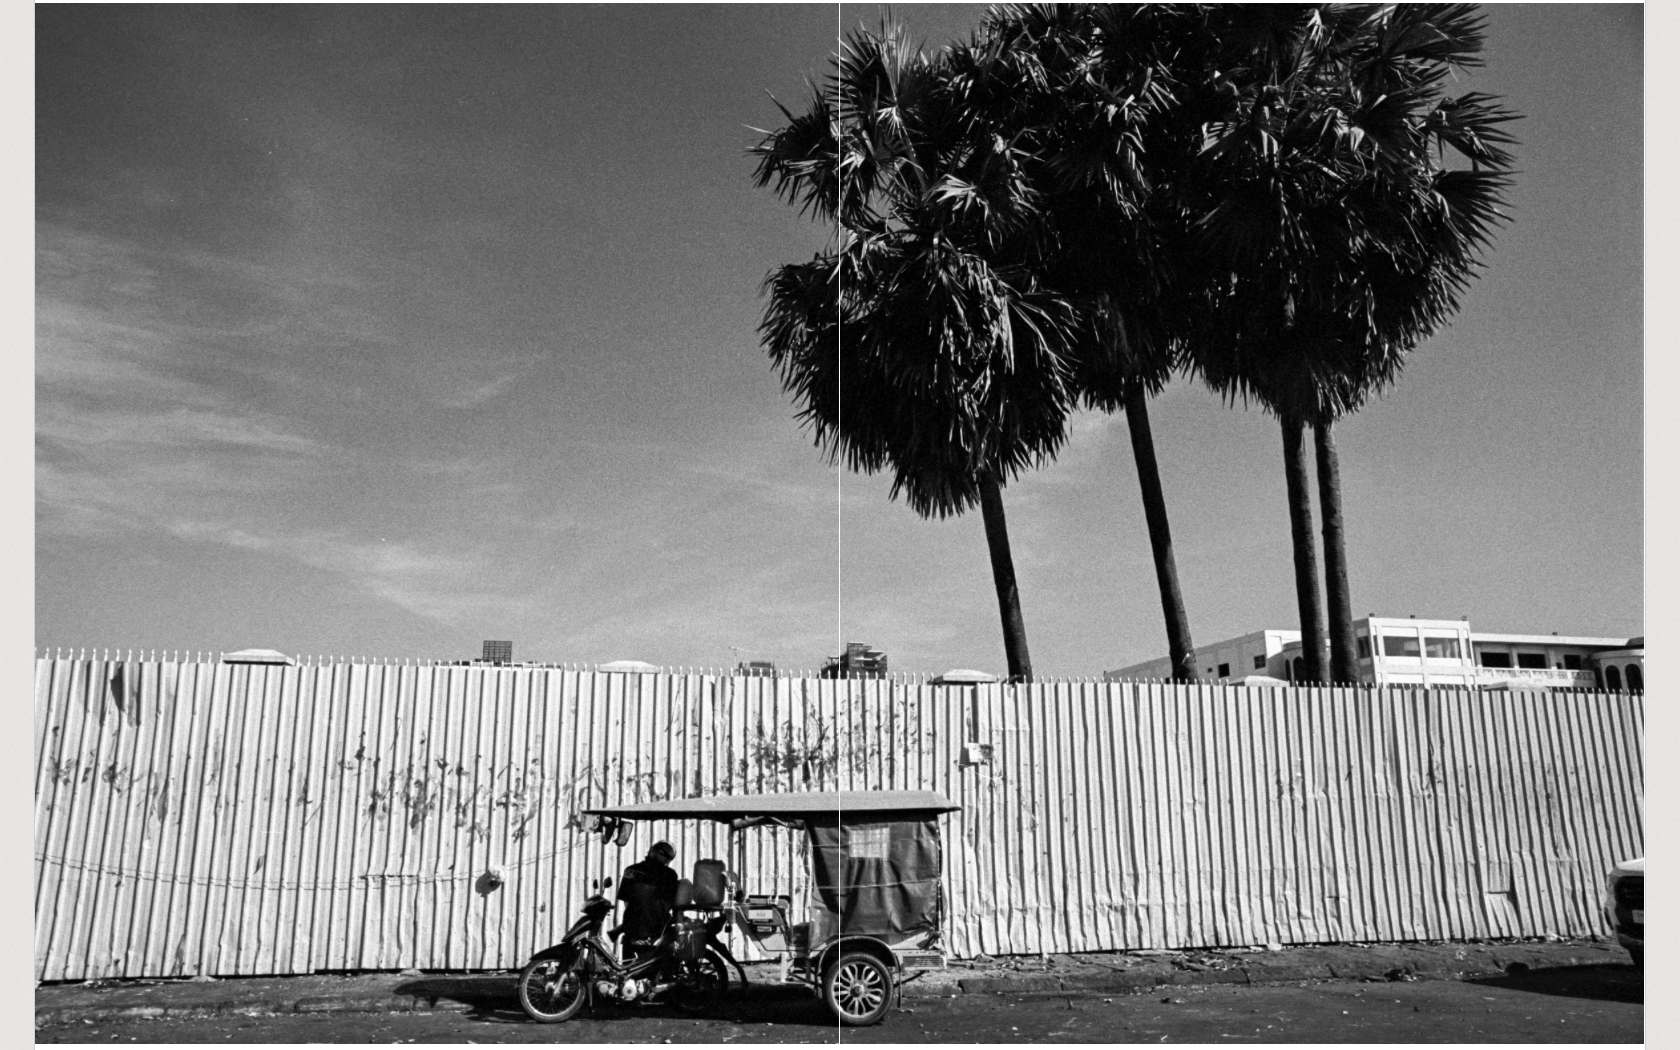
[949,5,1206,679]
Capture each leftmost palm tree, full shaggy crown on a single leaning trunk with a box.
[754,27,1079,680]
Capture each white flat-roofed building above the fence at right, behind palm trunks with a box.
[1102,617,1645,692]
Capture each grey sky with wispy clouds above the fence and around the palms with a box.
[34,5,1645,677]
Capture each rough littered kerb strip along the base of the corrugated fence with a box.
[35,941,1628,1026]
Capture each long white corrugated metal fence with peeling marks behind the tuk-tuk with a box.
[35,655,1645,979]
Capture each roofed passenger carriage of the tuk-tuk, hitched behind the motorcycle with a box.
[524,791,961,1025]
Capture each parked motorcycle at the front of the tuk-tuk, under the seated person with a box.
[519,879,729,1025]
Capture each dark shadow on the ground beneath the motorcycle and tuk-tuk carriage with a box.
[393,976,835,1030]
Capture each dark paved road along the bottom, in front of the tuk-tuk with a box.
[35,966,1645,1045]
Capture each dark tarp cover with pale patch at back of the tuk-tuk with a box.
[806,816,942,936]
